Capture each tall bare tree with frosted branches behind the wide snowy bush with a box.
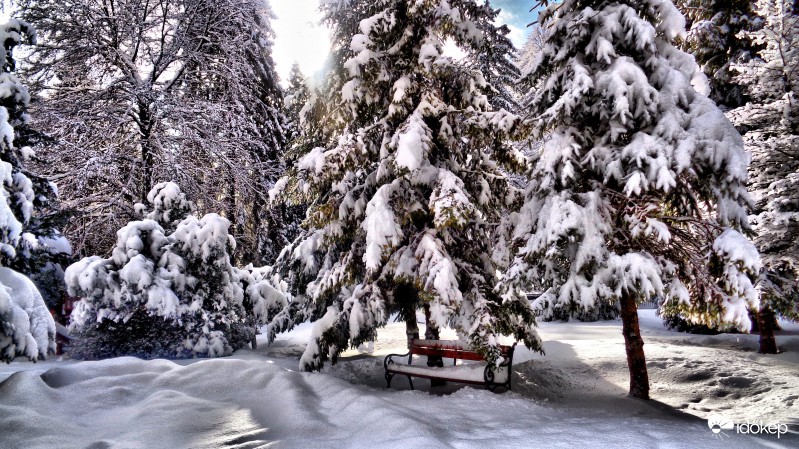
[19,0,284,262]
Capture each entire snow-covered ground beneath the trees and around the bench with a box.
[0,310,799,449]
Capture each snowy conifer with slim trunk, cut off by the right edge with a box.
[728,0,799,354]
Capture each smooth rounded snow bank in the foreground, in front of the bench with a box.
[0,358,776,449]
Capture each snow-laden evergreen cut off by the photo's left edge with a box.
[0,20,56,362]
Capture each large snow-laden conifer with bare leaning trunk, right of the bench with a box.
[510,0,759,398]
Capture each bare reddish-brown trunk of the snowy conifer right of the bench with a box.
[621,292,649,399]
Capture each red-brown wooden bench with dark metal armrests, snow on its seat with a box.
[383,340,516,391]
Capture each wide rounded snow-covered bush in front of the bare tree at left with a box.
[66,183,285,358]
